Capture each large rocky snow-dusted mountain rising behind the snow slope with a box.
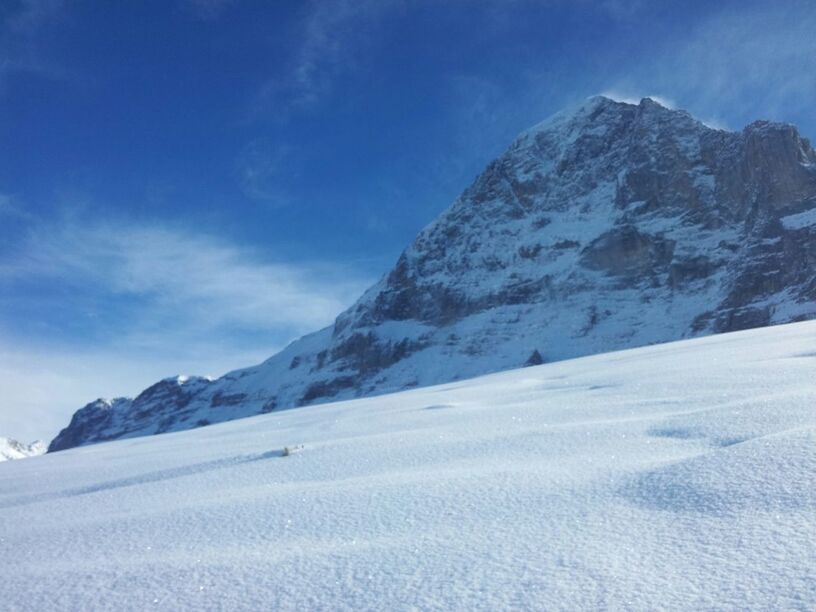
[49,97,816,451]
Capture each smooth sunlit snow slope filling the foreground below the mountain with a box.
[0,322,816,612]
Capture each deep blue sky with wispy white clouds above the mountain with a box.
[0,0,816,439]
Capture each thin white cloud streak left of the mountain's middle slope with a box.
[0,223,367,334]
